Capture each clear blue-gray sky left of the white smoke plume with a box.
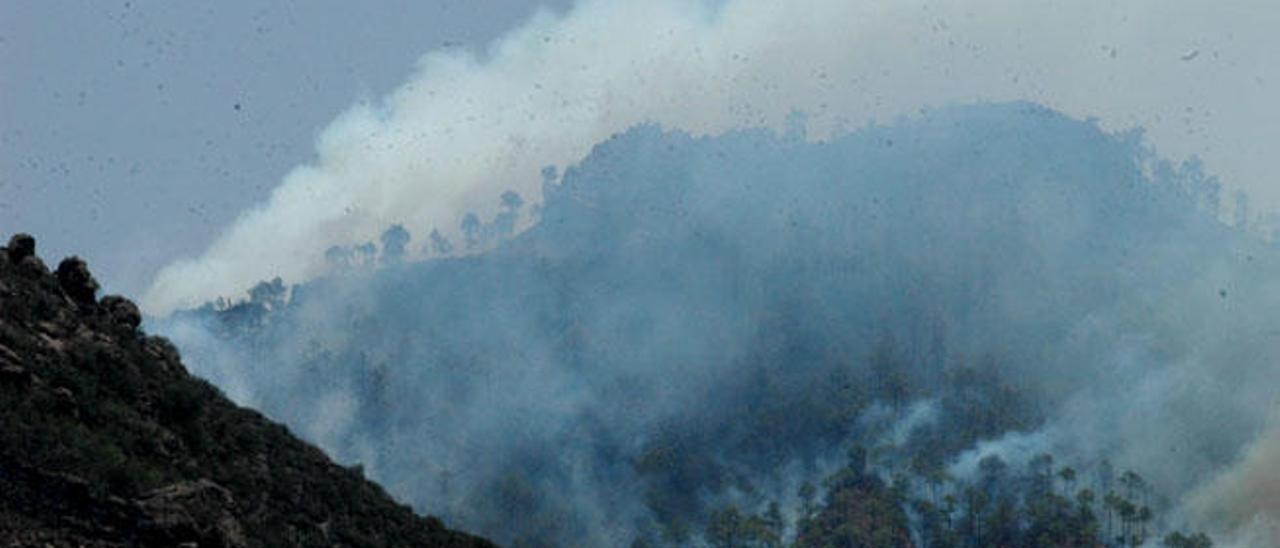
[0,0,568,293]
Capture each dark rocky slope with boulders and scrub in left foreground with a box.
[0,234,490,548]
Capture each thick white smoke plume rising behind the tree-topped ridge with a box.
[142,0,1280,314]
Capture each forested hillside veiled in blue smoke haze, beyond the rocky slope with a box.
[157,102,1259,547]
